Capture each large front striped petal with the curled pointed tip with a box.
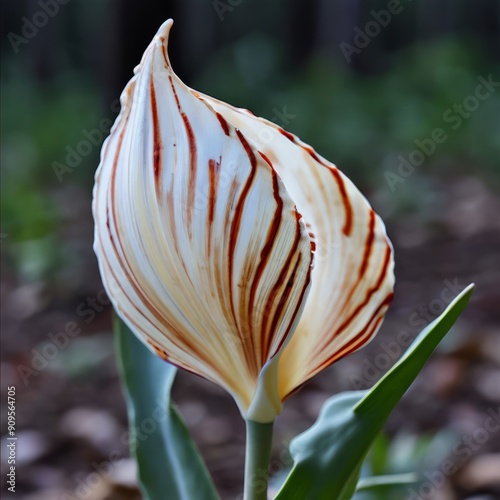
[93,21,312,422]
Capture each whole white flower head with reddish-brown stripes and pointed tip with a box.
[93,20,394,422]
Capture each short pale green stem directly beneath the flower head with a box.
[244,420,273,500]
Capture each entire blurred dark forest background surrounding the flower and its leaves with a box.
[1,0,500,500]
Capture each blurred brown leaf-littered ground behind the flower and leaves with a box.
[1,178,500,500]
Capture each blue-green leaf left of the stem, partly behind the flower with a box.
[115,317,219,500]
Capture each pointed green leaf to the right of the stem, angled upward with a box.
[276,285,473,500]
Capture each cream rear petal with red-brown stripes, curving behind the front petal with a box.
[195,93,394,399]
